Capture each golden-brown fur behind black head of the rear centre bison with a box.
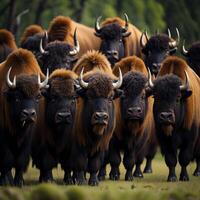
[102,17,142,58]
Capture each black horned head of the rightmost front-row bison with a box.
[149,72,192,135]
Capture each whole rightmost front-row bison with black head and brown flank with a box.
[149,57,200,181]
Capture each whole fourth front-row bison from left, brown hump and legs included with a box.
[99,56,156,181]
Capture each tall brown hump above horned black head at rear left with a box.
[48,16,72,43]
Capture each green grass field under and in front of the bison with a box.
[0,154,200,200]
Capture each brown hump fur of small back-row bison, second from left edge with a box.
[20,24,44,44]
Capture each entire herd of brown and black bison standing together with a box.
[0,14,200,186]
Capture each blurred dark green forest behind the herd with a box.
[0,0,200,44]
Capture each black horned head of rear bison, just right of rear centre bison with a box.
[140,28,180,76]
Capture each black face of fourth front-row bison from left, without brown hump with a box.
[121,71,148,133]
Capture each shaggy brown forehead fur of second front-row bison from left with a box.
[49,69,78,97]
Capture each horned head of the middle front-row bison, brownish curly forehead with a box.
[79,70,122,137]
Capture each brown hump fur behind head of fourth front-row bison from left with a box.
[113,56,148,76]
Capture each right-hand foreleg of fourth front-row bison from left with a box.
[123,150,135,181]
